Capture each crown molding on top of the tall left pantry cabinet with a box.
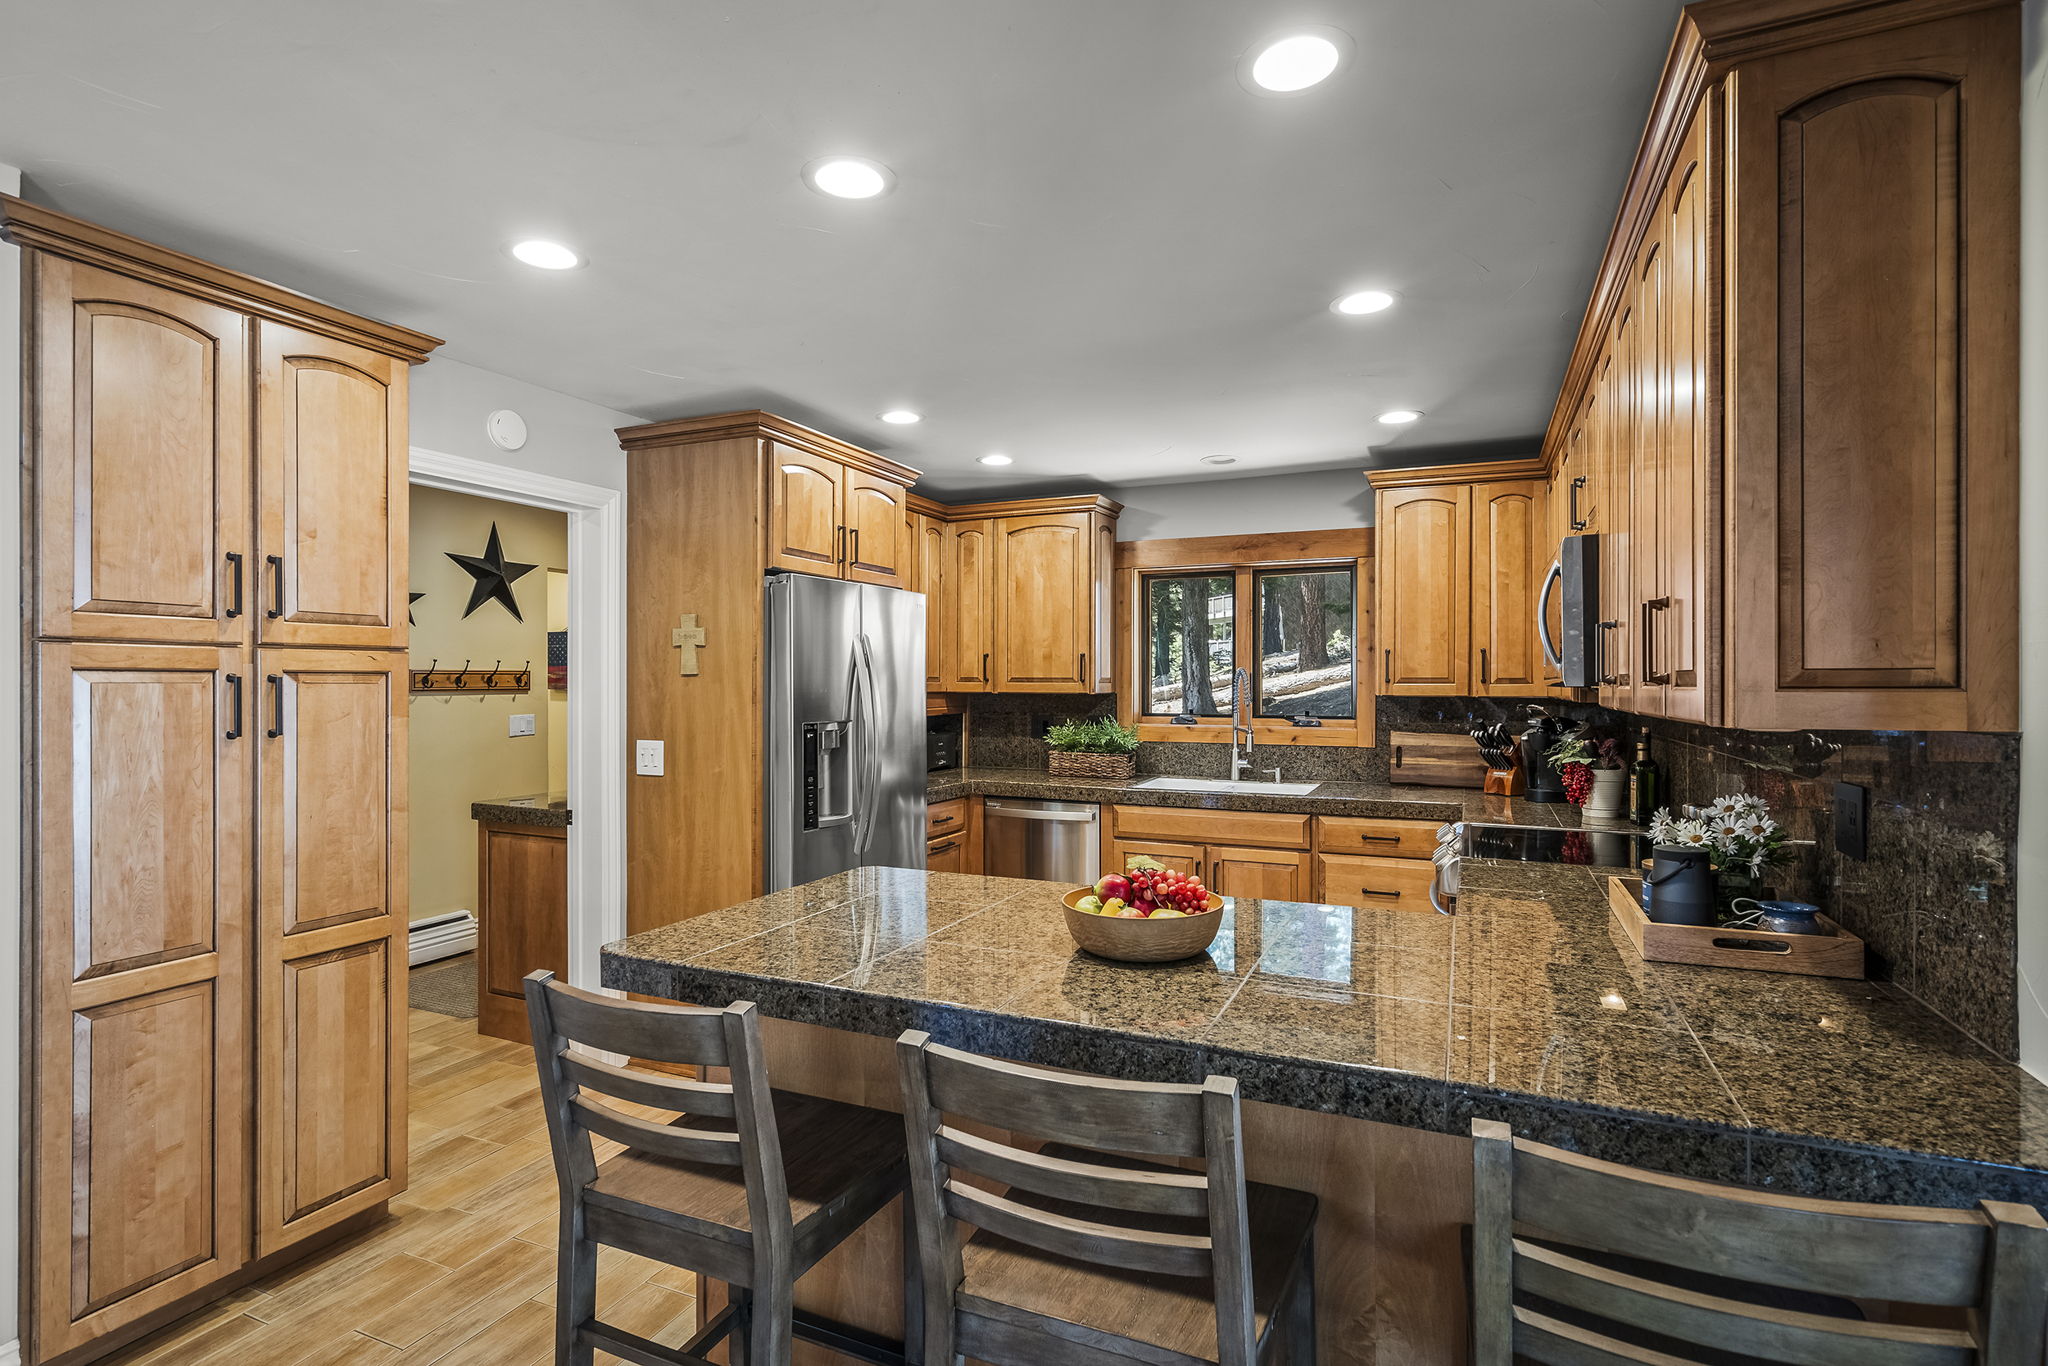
[0,195,440,365]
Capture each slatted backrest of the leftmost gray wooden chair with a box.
[526,971,791,1255]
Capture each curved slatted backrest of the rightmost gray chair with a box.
[1473,1120,2048,1366]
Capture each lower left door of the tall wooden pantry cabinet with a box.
[25,641,256,1360]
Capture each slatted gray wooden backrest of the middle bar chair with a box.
[897,1030,1255,1366]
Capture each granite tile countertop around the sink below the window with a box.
[926,768,1579,825]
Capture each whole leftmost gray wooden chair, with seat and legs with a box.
[526,971,920,1366]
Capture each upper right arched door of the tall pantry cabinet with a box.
[250,322,407,649]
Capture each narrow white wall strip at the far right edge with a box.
[2019,0,2048,1081]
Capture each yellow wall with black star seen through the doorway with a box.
[408,487,569,920]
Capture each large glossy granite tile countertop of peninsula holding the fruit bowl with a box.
[602,860,2048,1206]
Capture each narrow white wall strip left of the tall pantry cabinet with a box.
[0,157,27,1366]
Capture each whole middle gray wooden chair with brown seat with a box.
[897,1030,1315,1366]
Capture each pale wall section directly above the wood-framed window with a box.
[1102,461,1372,541]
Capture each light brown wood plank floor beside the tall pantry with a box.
[106,1010,696,1366]
